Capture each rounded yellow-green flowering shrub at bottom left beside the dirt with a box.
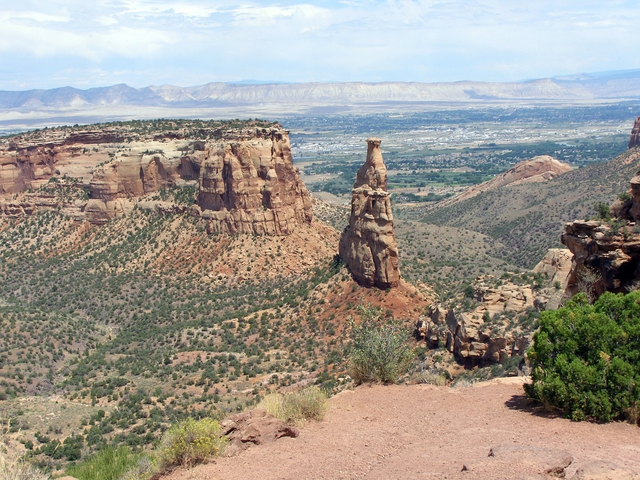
[157,418,227,470]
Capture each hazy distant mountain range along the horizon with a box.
[0,70,640,112]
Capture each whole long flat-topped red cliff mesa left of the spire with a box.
[0,121,312,235]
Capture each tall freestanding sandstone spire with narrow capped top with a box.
[340,138,400,288]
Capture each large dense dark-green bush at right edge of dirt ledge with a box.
[525,291,640,422]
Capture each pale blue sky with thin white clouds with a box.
[0,0,640,90]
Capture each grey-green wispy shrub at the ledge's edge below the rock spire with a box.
[349,305,415,384]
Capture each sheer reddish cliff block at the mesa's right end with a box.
[196,129,312,235]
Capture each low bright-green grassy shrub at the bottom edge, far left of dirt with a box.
[66,446,141,480]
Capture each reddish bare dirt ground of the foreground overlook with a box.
[165,378,640,480]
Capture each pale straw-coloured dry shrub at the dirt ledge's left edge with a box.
[258,386,329,425]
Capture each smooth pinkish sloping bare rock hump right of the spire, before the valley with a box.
[439,155,572,206]
